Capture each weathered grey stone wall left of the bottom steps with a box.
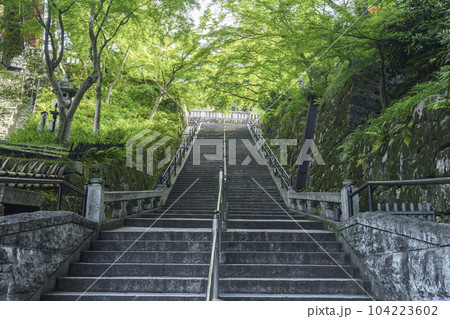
[0,211,97,300]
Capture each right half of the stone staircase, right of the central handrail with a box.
[219,126,369,300]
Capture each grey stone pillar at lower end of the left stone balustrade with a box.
[86,178,105,228]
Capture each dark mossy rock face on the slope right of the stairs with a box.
[308,81,450,212]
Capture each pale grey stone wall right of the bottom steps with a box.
[338,213,450,300]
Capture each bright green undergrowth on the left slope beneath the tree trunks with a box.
[8,78,184,163]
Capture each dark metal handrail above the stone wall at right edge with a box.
[348,177,450,217]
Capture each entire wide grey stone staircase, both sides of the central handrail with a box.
[42,124,368,300]
